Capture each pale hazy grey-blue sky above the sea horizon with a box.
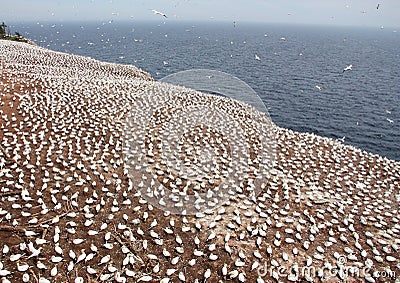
[0,0,400,27]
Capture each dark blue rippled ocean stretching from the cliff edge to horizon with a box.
[11,21,400,160]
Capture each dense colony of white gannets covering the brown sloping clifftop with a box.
[0,41,400,283]
